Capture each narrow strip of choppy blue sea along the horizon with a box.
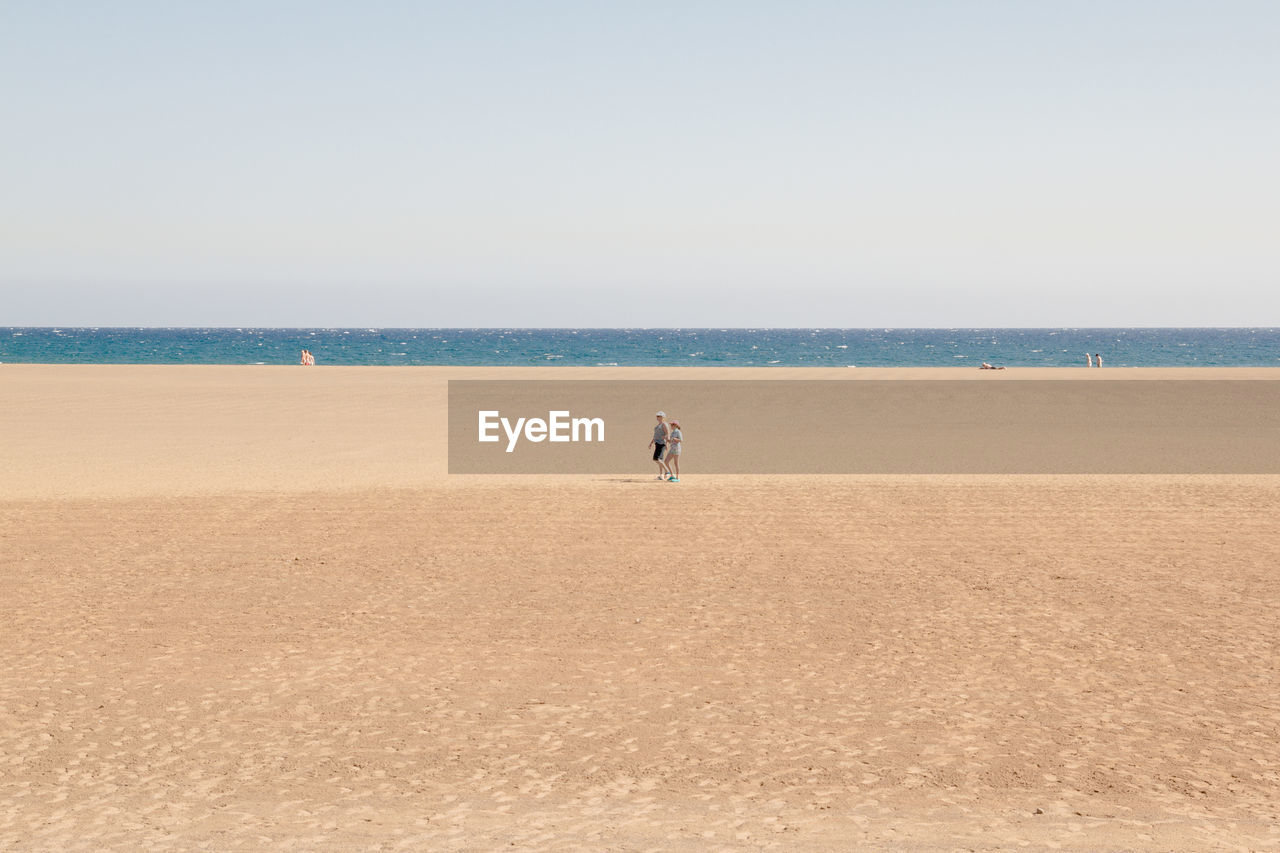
[0,327,1280,368]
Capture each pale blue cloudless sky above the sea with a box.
[0,0,1280,327]
